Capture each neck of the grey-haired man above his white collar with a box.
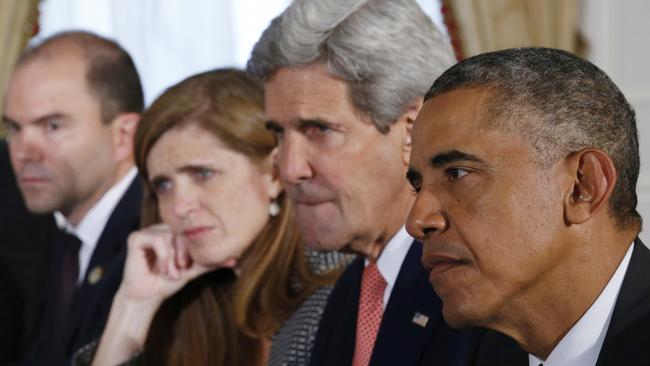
[347,188,413,263]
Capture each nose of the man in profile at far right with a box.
[406,190,448,241]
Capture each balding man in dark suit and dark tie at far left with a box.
[2,32,143,365]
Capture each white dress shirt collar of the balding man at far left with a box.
[54,167,138,284]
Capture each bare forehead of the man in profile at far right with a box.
[412,88,532,166]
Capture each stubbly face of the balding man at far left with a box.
[3,49,117,224]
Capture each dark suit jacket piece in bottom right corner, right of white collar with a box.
[596,239,650,366]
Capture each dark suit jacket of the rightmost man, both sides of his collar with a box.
[470,239,650,366]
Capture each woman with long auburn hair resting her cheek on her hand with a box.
[88,69,338,365]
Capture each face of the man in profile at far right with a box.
[407,89,571,327]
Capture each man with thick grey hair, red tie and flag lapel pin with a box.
[248,0,468,365]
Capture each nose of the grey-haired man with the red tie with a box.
[278,132,313,184]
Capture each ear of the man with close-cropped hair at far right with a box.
[564,149,616,224]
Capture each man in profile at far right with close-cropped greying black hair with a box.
[407,48,650,366]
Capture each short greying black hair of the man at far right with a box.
[425,48,641,229]
